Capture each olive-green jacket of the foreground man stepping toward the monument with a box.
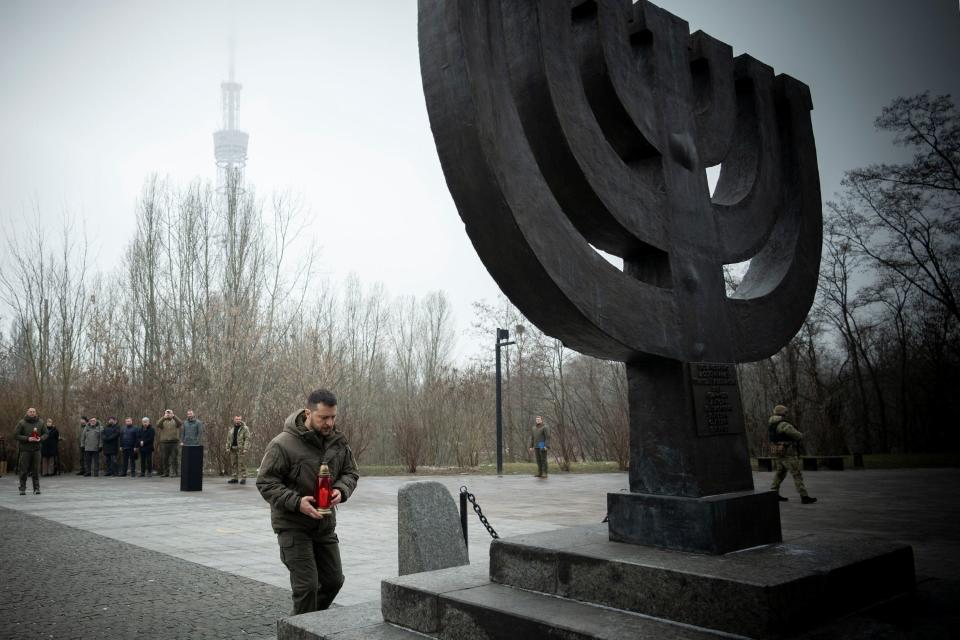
[257,411,360,532]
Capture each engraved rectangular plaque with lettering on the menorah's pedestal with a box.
[689,362,743,436]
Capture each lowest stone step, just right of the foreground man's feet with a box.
[277,600,424,640]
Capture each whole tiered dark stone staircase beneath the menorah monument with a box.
[278,526,914,640]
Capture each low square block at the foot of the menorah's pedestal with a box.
[607,491,783,554]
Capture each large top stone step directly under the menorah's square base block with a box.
[490,525,914,638]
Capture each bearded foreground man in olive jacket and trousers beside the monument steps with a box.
[257,389,359,615]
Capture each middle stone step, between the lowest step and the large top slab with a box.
[381,566,718,640]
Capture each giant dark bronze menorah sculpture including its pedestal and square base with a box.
[419,0,822,553]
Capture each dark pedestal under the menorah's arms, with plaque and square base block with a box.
[607,359,782,554]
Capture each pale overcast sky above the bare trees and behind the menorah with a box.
[0,0,960,354]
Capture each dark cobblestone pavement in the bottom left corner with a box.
[0,507,290,640]
